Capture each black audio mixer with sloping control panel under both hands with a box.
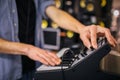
[34,38,111,80]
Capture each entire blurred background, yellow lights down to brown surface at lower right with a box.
[42,0,120,80]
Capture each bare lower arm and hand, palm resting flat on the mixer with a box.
[0,39,60,65]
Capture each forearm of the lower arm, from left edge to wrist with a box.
[0,39,29,55]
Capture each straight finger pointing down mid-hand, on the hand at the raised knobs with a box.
[90,25,97,49]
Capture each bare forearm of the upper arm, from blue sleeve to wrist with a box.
[46,6,85,33]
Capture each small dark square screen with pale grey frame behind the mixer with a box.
[41,28,60,50]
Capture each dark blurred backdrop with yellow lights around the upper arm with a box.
[42,0,120,50]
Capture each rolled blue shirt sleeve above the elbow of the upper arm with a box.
[38,0,55,18]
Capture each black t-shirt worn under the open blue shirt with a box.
[16,0,36,73]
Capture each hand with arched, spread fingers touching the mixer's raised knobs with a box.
[79,25,117,49]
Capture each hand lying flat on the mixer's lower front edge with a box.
[26,46,61,66]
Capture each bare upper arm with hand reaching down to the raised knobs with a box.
[46,6,117,48]
